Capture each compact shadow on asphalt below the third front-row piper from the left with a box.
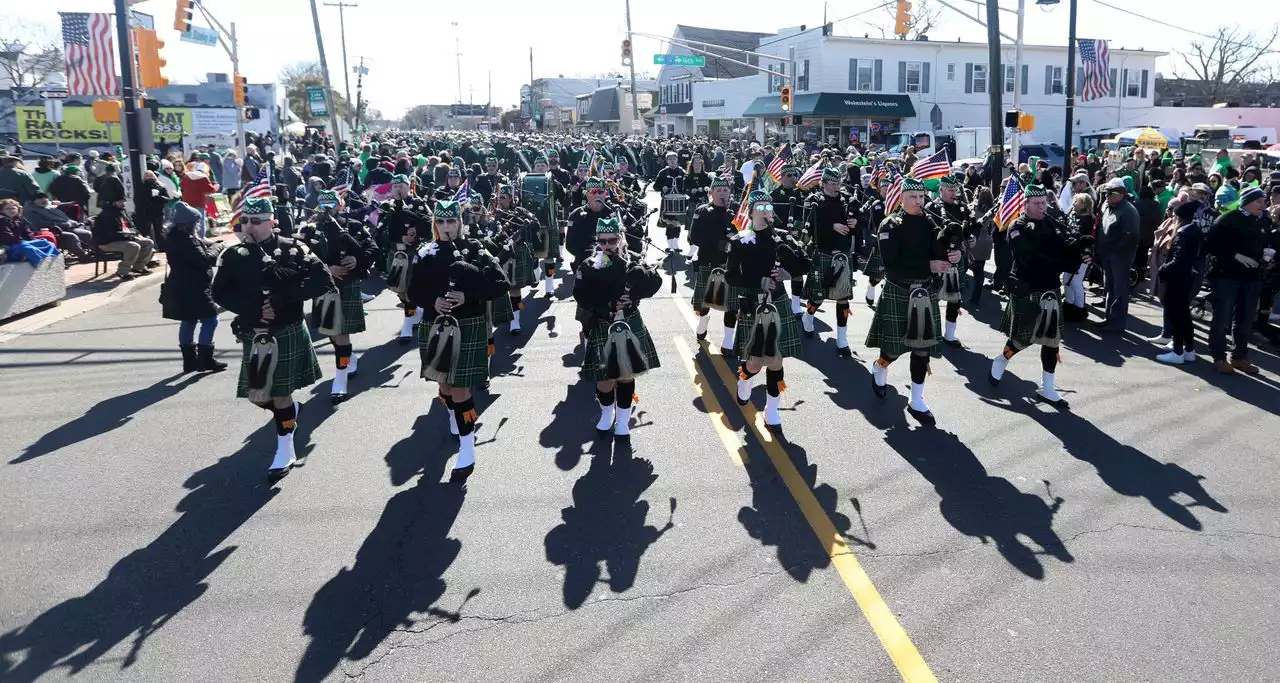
[544,440,676,609]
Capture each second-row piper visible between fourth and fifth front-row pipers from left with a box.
[801,166,861,357]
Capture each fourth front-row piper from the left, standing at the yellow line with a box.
[726,189,810,428]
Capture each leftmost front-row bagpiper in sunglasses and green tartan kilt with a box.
[212,197,334,480]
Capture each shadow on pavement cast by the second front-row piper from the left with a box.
[296,416,480,682]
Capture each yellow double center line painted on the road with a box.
[672,299,937,683]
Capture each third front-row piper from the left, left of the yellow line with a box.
[573,217,662,439]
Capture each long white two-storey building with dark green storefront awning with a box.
[677,27,1164,151]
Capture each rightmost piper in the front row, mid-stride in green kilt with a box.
[989,185,1092,409]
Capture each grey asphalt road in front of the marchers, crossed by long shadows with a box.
[0,203,1280,682]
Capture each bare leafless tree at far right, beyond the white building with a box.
[1174,26,1280,102]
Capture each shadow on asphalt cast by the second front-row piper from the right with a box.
[884,422,1075,579]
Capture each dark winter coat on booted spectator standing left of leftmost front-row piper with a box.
[160,225,221,320]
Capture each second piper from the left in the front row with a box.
[408,200,508,481]
